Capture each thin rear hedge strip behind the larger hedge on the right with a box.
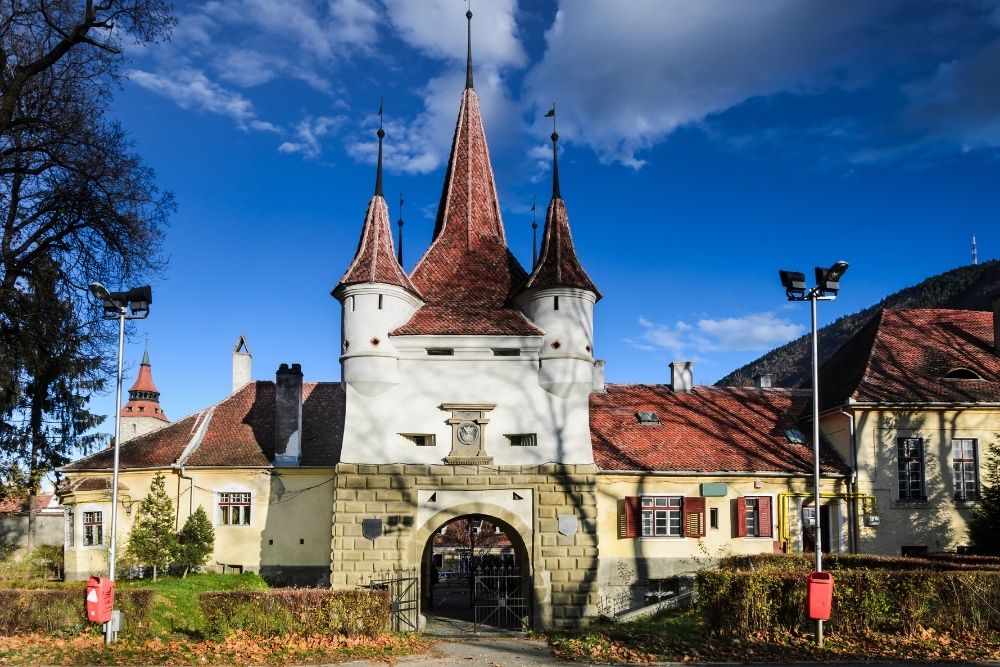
[719,553,1000,572]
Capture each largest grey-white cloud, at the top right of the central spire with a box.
[527,0,889,168]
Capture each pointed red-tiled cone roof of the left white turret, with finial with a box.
[333,127,420,296]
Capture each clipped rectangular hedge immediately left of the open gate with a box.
[198,588,389,638]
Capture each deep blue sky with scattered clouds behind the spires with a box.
[93,0,1000,430]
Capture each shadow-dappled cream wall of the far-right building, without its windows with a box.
[822,406,1000,555]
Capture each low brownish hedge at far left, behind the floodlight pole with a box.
[0,585,153,637]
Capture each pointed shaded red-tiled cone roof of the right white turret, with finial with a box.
[522,132,601,299]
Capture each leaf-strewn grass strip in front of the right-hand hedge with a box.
[546,610,1000,663]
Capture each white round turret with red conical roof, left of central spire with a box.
[332,121,423,396]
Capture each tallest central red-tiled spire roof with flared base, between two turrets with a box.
[393,8,540,335]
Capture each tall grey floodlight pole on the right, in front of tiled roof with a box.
[778,261,848,648]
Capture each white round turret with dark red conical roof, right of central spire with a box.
[516,124,601,397]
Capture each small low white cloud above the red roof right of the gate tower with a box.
[627,312,805,356]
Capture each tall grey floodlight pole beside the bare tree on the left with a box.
[90,283,153,644]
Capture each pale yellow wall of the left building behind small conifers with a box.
[63,468,334,585]
